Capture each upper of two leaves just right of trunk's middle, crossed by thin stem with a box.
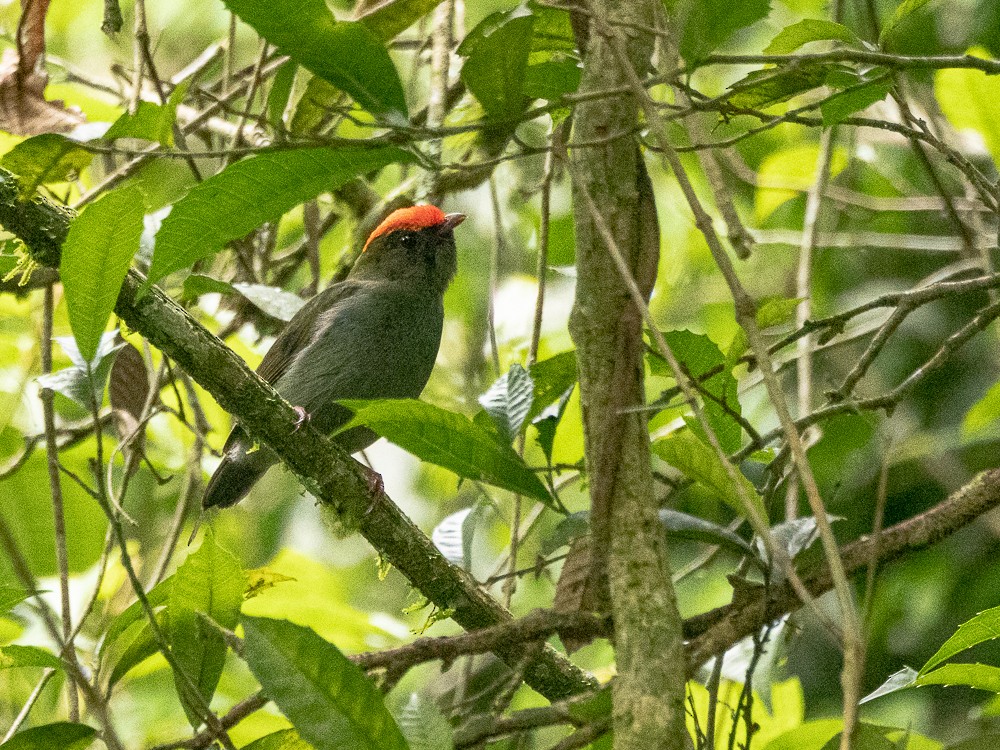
[649,330,743,453]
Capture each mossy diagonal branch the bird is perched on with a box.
[0,169,595,700]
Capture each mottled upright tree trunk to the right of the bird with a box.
[570,0,686,750]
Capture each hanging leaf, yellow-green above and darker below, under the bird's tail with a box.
[167,532,246,728]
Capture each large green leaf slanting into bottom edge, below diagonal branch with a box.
[243,617,408,750]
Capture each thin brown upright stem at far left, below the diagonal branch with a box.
[39,284,77,721]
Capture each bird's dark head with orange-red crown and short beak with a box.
[352,206,465,293]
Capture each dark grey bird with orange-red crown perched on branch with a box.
[202,205,465,510]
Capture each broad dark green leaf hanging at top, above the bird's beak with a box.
[459,15,535,121]
